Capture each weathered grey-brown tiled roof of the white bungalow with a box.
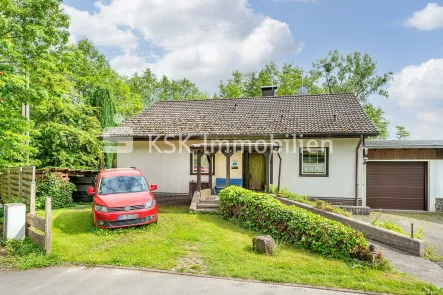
[104,94,378,137]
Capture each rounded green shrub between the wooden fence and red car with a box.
[35,173,76,209]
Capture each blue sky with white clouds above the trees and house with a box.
[64,0,443,139]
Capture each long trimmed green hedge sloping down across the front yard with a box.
[219,186,368,260]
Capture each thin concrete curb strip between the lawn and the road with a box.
[92,265,389,295]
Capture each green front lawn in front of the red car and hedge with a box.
[48,207,438,294]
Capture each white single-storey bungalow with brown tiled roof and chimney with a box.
[103,87,388,209]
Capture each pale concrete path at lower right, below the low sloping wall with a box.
[368,241,443,288]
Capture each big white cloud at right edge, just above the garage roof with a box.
[388,59,443,139]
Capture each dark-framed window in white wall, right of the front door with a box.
[300,148,329,177]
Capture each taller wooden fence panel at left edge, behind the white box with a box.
[0,166,36,211]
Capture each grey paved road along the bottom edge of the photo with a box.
[0,267,366,295]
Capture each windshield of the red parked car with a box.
[98,176,148,194]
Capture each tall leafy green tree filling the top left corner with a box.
[0,0,69,168]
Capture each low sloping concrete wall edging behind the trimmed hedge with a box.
[274,196,425,257]
